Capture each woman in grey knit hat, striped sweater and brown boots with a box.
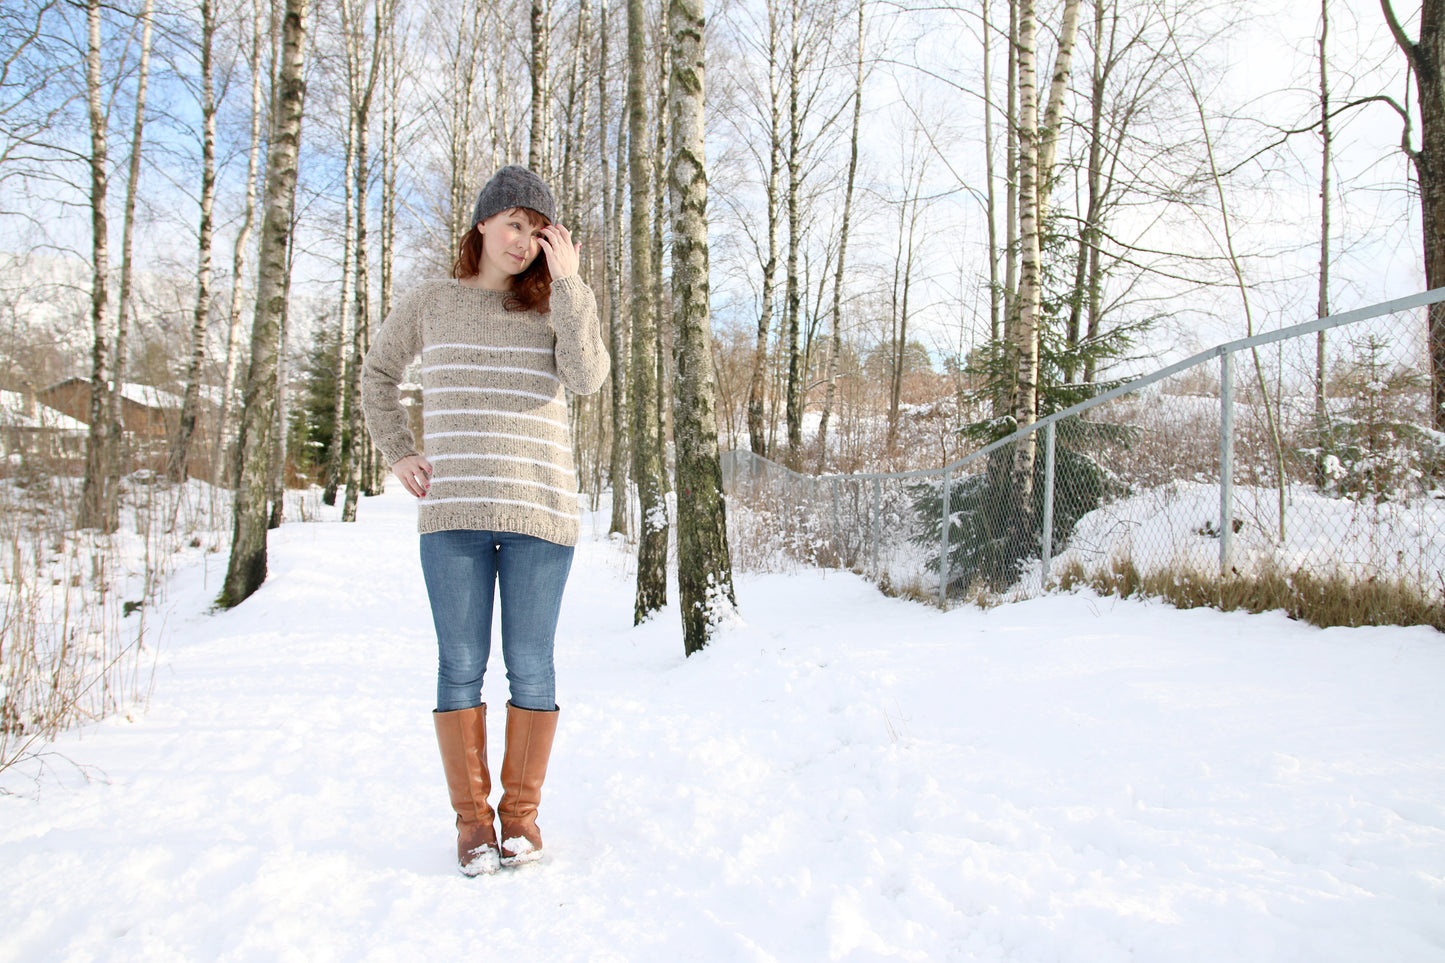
[361,166,608,876]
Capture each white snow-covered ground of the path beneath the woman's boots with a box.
[0,490,1445,963]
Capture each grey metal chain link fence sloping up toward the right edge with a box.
[723,289,1445,629]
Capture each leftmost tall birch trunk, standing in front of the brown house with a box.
[75,0,120,532]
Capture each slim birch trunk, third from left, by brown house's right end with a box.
[168,0,221,482]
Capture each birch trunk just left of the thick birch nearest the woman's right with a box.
[627,0,668,625]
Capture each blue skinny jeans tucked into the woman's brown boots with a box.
[422,529,572,713]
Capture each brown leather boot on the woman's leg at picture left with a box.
[432,704,501,876]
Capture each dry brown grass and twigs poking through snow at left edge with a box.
[0,451,224,771]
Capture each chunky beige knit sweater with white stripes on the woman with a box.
[361,275,610,545]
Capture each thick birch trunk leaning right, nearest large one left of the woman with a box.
[220,0,306,607]
